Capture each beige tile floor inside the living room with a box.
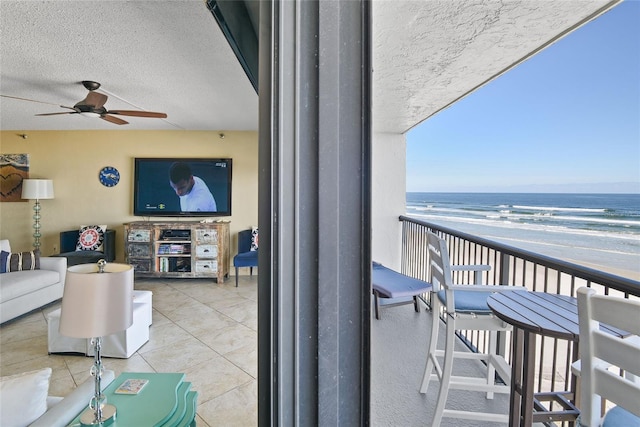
[0,275,258,427]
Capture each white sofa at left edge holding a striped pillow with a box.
[0,240,67,323]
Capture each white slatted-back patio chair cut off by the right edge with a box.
[573,287,640,427]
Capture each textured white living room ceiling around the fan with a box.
[0,0,258,130]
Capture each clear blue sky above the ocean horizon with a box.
[407,0,640,193]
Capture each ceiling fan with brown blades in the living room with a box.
[2,80,167,125]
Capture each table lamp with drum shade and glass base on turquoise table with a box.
[60,260,133,426]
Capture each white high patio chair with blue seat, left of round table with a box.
[420,232,524,427]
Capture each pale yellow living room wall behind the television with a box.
[0,130,258,262]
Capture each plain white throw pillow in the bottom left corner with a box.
[0,368,51,427]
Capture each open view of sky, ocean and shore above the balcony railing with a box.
[406,1,640,280]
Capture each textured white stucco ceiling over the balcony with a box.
[373,0,619,133]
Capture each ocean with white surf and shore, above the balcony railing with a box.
[407,193,640,280]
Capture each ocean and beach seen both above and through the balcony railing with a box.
[406,192,640,414]
